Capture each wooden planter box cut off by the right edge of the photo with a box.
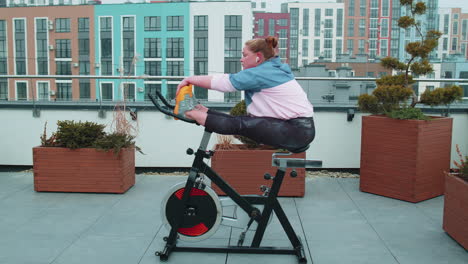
[443,174,468,250]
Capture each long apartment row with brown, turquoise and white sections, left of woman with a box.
[0,1,253,101]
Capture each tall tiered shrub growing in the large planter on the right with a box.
[358,0,462,120]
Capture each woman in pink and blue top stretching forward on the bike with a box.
[177,36,315,152]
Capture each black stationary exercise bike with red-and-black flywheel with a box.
[148,89,322,263]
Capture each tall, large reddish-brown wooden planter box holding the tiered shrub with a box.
[360,116,452,202]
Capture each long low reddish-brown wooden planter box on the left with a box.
[33,147,135,193]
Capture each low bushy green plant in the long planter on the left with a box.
[41,120,143,155]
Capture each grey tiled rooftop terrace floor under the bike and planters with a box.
[0,171,468,264]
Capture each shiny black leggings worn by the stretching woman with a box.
[205,110,315,152]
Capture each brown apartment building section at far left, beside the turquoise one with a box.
[0,5,95,101]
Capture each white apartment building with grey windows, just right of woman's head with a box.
[281,2,345,68]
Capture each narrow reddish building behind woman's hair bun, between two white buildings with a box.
[253,13,290,63]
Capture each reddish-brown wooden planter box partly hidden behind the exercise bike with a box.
[211,145,306,197]
